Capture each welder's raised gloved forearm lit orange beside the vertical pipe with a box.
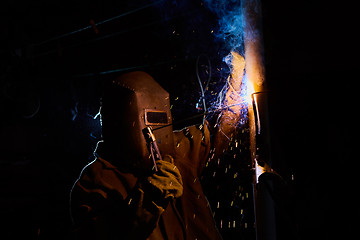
[214,52,245,155]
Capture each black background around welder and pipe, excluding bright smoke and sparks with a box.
[0,0,360,239]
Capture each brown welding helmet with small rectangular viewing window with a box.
[101,71,174,170]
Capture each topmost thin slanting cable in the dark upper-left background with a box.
[35,0,164,46]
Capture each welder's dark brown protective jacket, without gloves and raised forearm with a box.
[71,125,221,240]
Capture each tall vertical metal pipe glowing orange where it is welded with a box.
[242,0,276,240]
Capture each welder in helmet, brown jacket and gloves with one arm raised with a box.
[71,62,245,240]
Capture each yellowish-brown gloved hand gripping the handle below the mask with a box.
[146,156,183,199]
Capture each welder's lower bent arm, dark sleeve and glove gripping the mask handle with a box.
[72,158,182,240]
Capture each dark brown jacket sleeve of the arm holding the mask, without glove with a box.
[70,159,164,240]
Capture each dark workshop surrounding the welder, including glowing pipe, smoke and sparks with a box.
[0,0,360,240]
